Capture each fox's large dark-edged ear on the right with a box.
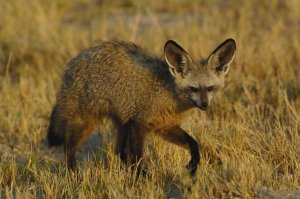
[207,39,236,74]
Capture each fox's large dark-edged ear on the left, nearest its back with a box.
[164,40,194,76]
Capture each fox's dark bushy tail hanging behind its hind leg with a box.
[47,106,64,147]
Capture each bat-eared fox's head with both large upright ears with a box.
[164,39,236,110]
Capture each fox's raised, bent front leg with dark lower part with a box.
[163,127,200,176]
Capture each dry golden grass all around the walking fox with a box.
[0,0,300,198]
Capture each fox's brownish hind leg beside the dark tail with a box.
[65,116,96,170]
